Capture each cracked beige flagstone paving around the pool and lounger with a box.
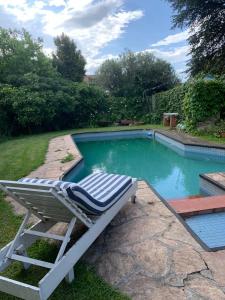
[3,136,225,300]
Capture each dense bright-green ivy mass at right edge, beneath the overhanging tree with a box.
[184,79,225,130]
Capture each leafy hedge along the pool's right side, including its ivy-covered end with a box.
[150,79,225,130]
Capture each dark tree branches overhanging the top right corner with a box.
[167,0,225,75]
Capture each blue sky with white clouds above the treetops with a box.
[0,0,189,79]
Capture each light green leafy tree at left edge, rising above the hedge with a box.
[0,27,55,85]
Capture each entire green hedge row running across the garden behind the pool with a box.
[0,74,225,135]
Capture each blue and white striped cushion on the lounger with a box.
[19,173,132,214]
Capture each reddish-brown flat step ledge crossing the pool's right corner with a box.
[169,195,225,217]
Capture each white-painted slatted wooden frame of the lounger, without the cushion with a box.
[0,180,137,300]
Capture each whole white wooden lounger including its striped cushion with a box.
[0,173,137,300]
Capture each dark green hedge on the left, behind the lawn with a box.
[0,78,108,136]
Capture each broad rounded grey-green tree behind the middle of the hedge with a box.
[96,51,179,97]
